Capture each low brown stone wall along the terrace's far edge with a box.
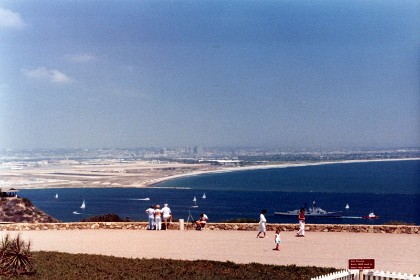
[0,222,420,234]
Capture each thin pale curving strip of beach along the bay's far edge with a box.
[145,158,420,188]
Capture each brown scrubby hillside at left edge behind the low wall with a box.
[0,197,59,223]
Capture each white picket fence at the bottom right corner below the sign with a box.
[311,270,420,280]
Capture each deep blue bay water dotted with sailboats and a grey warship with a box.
[20,160,420,225]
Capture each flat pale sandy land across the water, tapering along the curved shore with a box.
[0,158,419,189]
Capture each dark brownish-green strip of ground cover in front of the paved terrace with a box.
[18,251,337,280]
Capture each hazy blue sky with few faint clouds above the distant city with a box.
[0,0,420,149]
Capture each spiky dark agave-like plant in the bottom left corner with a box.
[0,234,33,275]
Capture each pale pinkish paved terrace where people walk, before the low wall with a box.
[0,230,420,273]
